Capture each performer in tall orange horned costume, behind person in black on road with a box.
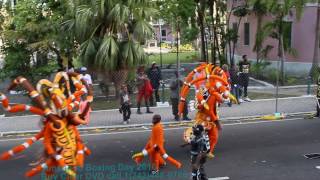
[179,63,236,158]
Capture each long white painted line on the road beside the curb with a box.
[0,118,303,142]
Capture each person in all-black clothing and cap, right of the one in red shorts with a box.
[147,62,162,106]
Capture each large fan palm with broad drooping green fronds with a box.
[63,0,157,95]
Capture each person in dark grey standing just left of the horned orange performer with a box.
[170,71,191,121]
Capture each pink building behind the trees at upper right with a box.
[228,0,320,75]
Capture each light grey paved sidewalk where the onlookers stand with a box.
[0,96,316,133]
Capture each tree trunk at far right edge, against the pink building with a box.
[310,0,320,80]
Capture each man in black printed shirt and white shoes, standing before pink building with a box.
[239,55,251,102]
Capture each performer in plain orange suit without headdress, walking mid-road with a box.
[132,114,182,174]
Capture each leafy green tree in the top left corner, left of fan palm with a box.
[2,0,70,79]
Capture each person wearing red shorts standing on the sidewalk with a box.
[136,66,153,114]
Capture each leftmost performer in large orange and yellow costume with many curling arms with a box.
[0,72,93,179]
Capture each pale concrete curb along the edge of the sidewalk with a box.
[0,111,316,137]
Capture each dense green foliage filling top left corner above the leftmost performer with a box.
[0,0,75,80]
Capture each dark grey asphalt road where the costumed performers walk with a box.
[0,119,320,180]
